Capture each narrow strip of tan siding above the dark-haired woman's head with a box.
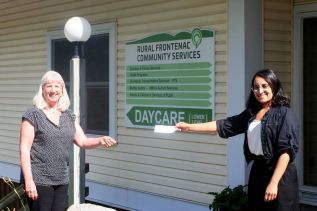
[263,0,293,96]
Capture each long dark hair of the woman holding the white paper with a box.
[246,69,290,114]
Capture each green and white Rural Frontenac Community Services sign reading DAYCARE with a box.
[125,28,215,128]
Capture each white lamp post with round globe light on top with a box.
[64,17,91,204]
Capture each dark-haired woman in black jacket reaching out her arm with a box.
[176,69,299,211]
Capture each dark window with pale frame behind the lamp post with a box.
[49,22,116,135]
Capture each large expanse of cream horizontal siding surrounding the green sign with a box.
[0,0,227,204]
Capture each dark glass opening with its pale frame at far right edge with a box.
[292,4,317,206]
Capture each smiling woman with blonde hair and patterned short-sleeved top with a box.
[20,71,117,211]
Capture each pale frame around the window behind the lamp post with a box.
[47,23,117,138]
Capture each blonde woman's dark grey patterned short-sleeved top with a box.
[22,107,75,186]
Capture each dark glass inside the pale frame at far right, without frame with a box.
[303,17,317,186]
